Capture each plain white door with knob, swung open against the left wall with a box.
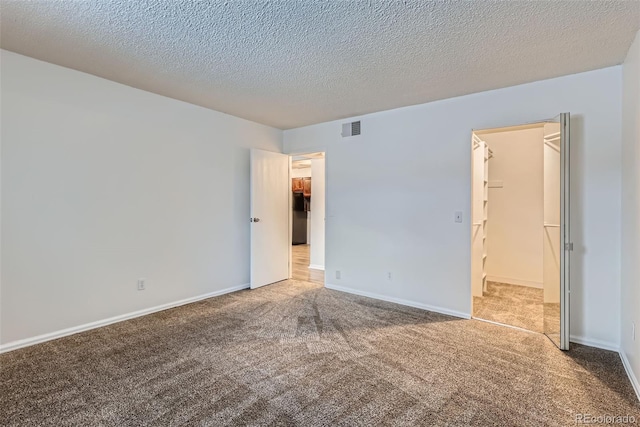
[250,149,291,289]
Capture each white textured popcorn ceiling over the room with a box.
[0,0,640,129]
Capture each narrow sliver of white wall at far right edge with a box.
[620,32,640,397]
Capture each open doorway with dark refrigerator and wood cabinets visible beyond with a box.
[290,152,325,285]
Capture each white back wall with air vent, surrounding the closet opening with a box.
[284,66,622,348]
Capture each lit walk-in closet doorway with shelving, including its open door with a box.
[471,113,572,350]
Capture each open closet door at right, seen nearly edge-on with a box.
[543,113,573,350]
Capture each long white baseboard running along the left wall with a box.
[0,283,249,353]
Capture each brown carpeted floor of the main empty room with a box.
[0,281,640,426]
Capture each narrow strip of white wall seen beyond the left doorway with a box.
[309,159,325,270]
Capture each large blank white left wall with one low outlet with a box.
[0,51,282,348]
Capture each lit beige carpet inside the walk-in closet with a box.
[473,282,544,332]
